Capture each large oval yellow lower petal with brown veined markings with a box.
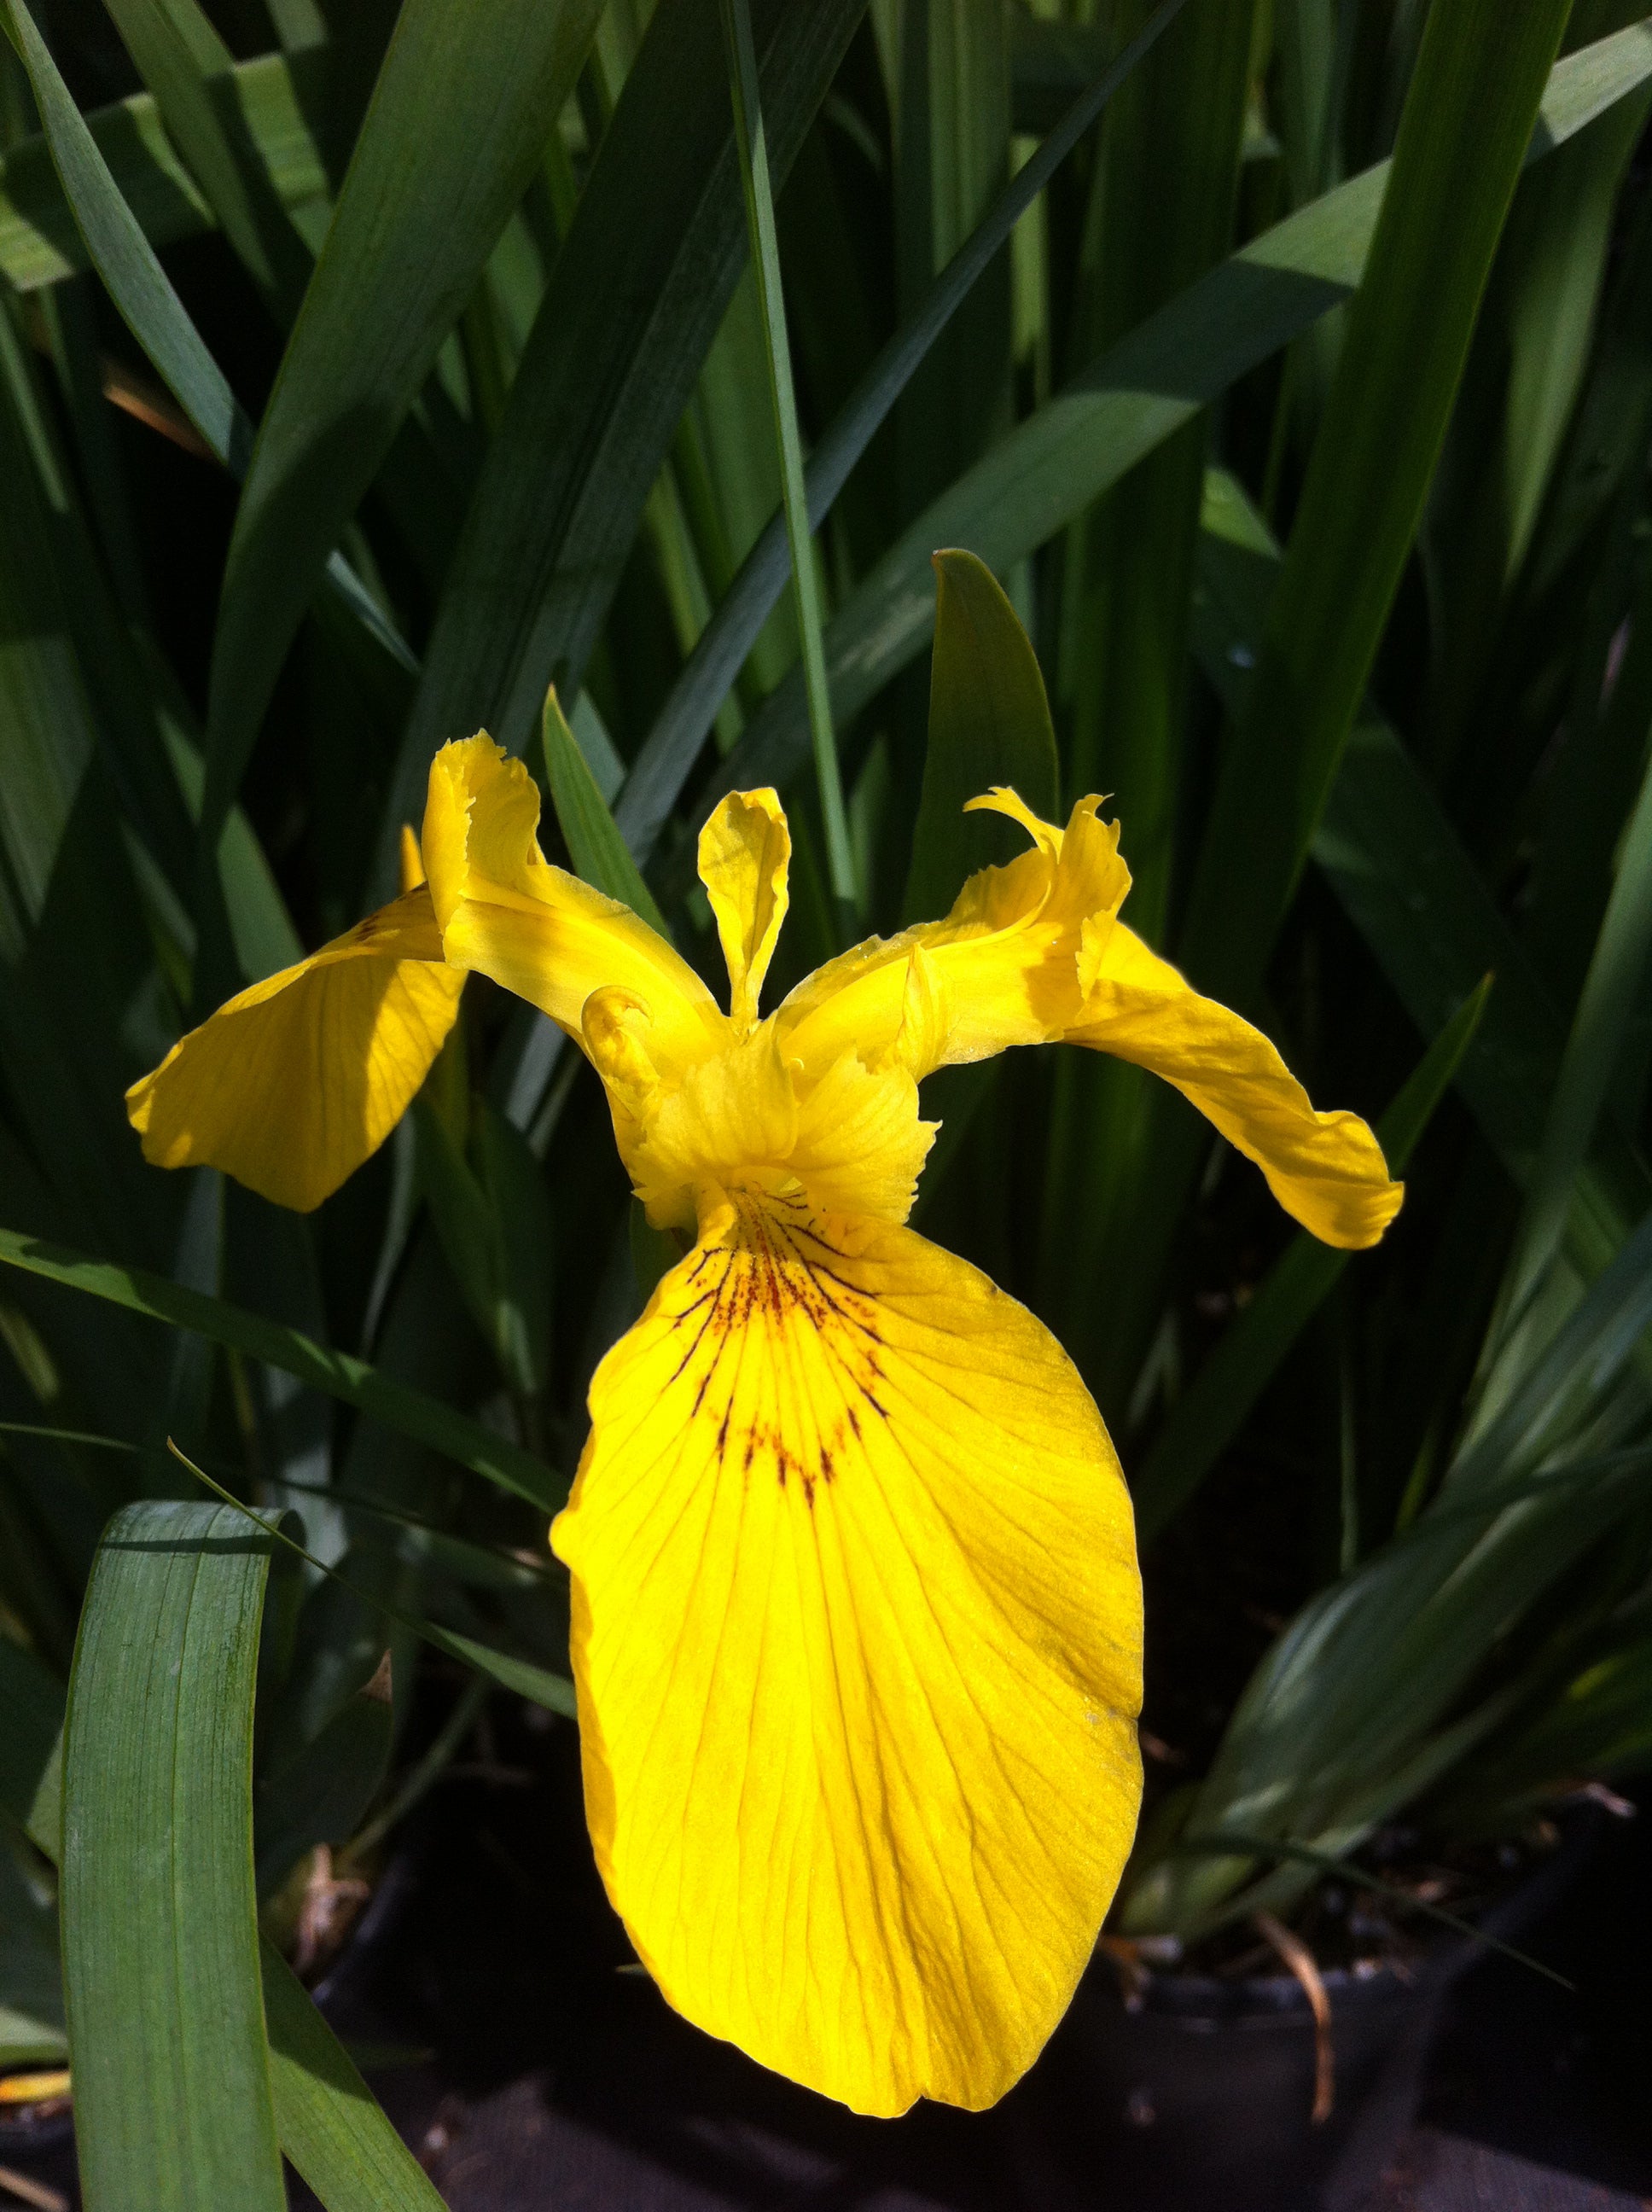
[550,1192,1141,2112]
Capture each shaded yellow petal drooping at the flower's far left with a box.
[126,889,464,1212]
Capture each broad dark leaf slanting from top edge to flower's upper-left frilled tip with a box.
[378,0,863,882]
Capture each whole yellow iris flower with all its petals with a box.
[128,736,1400,2112]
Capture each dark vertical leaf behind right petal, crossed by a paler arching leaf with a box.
[1038,0,1256,1362]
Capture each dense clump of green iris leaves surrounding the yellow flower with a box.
[0,0,1652,2205]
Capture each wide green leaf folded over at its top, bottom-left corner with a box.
[62,1499,285,2212]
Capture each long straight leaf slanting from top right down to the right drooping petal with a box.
[1181,0,1570,1006]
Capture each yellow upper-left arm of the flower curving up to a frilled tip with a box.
[422,735,728,1066]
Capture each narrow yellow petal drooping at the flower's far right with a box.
[1066,923,1405,1249]
